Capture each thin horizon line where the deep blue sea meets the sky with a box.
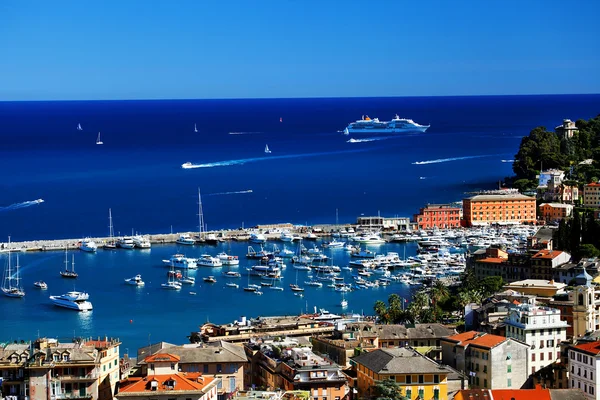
[0,93,600,103]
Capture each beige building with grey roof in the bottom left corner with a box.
[0,338,120,400]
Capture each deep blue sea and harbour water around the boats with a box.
[0,95,600,351]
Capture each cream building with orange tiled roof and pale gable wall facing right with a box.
[442,331,529,389]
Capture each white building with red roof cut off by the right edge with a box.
[569,341,600,400]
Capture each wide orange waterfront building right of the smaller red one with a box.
[463,194,536,226]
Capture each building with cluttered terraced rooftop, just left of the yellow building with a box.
[244,338,350,400]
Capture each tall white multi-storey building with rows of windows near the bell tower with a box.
[505,299,567,374]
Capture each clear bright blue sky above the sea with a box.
[0,0,600,100]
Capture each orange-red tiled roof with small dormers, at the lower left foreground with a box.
[119,372,214,397]
